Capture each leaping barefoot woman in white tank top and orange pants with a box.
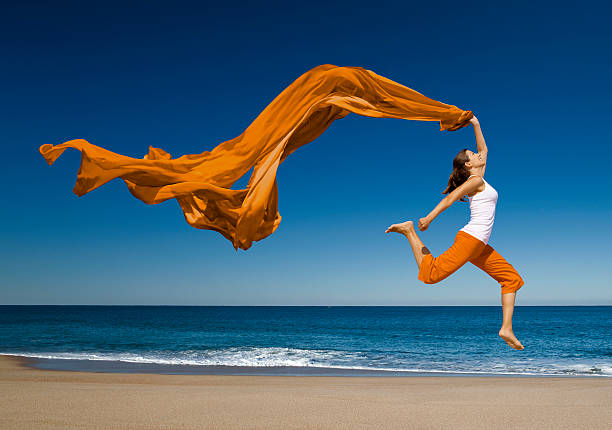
[385,116,524,349]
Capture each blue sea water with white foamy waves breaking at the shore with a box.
[0,306,612,377]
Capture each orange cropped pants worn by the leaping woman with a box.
[419,231,525,294]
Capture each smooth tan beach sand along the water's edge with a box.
[0,356,612,430]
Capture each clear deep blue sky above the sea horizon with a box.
[0,1,612,305]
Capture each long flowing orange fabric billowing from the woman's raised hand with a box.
[40,64,473,250]
